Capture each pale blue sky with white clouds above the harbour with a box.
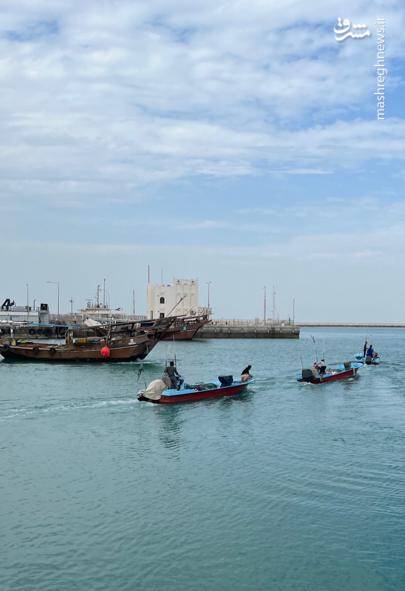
[0,0,405,322]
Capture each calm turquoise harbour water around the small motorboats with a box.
[0,329,405,591]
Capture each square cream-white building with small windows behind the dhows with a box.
[148,279,202,319]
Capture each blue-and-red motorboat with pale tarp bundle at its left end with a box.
[138,376,254,404]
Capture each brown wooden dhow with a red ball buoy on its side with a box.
[0,319,171,363]
